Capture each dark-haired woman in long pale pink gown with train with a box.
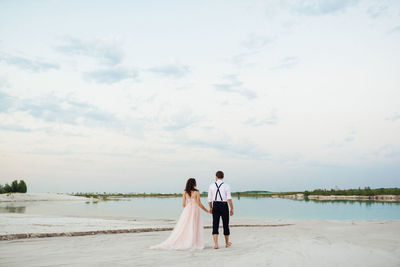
[150,178,210,250]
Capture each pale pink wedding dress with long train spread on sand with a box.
[150,196,204,250]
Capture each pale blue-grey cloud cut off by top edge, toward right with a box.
[288,0,358,16]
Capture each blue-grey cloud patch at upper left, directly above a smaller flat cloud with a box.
[54,37,123,66]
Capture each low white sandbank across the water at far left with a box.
[0,193,90,202]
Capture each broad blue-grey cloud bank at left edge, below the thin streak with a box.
[0,91,144,136]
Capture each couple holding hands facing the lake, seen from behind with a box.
[150,171,233,250]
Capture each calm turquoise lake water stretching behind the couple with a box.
[0,197,400,220]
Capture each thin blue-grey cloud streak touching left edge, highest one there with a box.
[0,54,60,72]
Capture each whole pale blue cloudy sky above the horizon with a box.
[0,0,400,192]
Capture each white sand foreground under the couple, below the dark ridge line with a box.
[0,221,400,267]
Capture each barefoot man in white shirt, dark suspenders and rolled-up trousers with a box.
[208,171,233,249]
